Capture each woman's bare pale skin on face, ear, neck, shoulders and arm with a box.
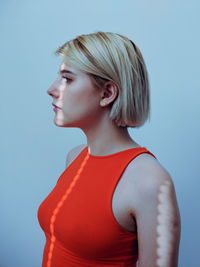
[47,62,181,267]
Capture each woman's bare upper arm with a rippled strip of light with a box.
[134,166,181,267]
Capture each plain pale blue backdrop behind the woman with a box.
[0,0,200,267]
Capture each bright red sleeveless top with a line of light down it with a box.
[37,146,156,267]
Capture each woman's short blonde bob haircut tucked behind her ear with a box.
[54,31,150,128]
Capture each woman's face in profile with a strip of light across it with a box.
[47,63,102,128]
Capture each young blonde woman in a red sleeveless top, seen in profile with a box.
[38,32,181,267]
